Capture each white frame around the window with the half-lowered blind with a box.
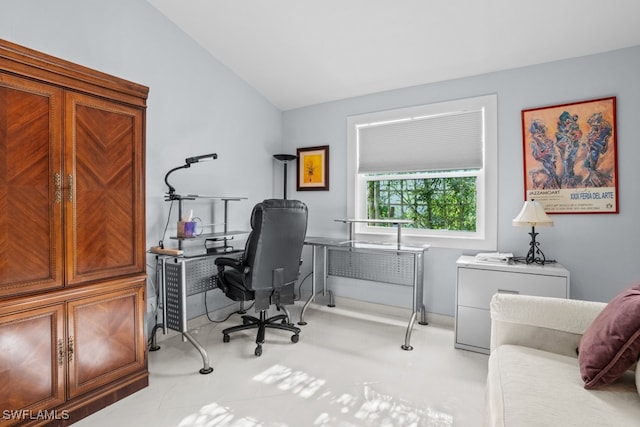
[347,94,498,251]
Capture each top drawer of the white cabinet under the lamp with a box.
[458,268,567,310]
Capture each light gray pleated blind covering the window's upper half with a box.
[358,109,483,173]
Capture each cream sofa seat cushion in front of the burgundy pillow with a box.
[484,345,640,427]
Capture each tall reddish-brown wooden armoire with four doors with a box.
[0,40,148,426]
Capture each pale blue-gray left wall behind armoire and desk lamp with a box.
[0,0,282,328]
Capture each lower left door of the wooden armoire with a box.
[0,304,66,418]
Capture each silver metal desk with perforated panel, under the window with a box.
[299,236,429,350]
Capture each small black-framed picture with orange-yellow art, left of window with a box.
[296,145,329,191]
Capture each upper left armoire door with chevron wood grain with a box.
[0,72,64,298]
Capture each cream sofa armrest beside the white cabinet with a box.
[491,294,607,357]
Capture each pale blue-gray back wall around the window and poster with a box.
[284,47,640,315]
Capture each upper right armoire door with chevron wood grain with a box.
[63,92,145,285]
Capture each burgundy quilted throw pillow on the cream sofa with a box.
[578,285,640,389]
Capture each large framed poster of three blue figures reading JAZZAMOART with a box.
[522,97,618,214]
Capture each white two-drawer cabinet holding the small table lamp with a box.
[455,255,569,354]
